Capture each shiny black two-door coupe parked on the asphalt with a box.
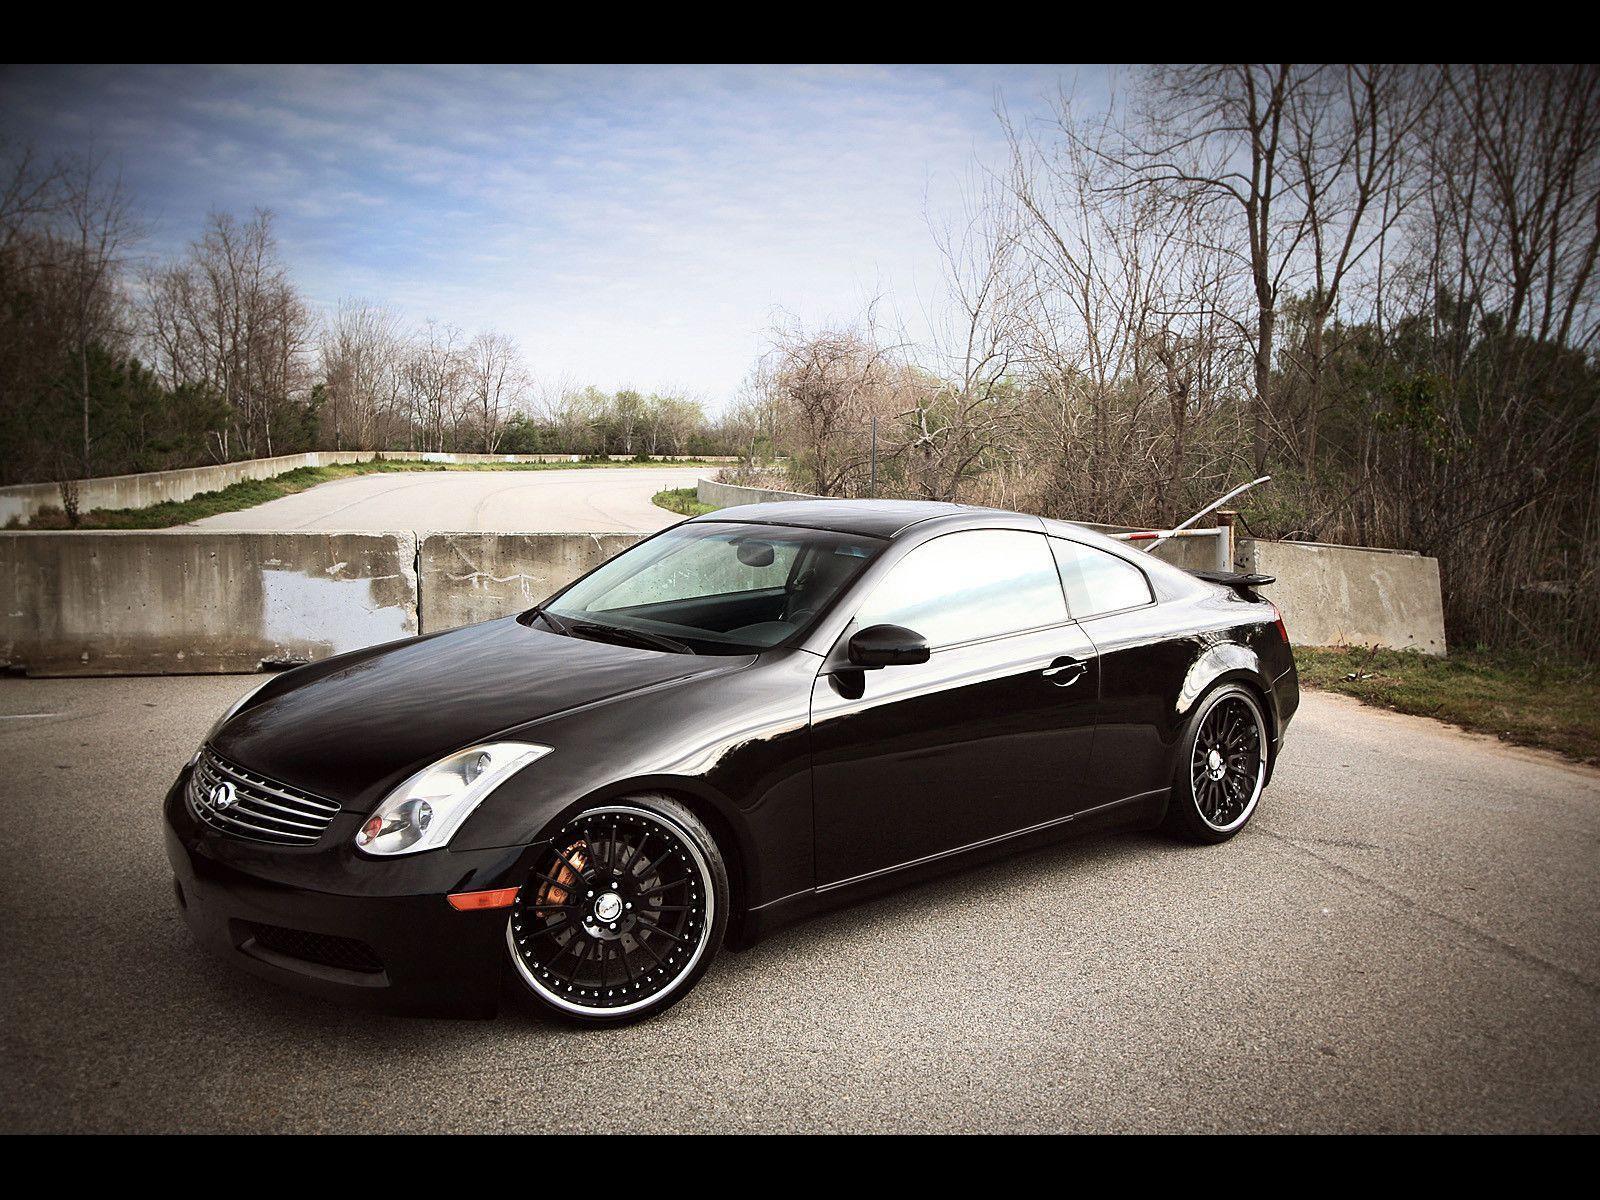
[165,501,1299,1024]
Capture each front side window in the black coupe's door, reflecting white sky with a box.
[856,530,1067,646]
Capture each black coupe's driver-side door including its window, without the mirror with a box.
[811,530,1099,885]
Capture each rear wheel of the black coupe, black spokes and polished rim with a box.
[1162,683,1270,845]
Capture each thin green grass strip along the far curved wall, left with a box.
[8,459,715,530]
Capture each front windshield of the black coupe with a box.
[528,522,883,654]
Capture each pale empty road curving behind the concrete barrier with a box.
[186,467,706,533]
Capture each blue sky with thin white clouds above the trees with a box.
[0,67,1107,410]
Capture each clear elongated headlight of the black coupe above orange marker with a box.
[355,742,550,854]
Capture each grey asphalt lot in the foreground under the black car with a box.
[0,677,1600,1133]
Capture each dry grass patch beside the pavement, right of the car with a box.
[1294,646,1600,763]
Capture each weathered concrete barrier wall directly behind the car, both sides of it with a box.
[0,515,1445,675]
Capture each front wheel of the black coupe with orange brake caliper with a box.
[506,794,728,1026]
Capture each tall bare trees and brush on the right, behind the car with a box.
[739,64,1600,658]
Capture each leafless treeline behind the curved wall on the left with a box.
[0,155,736,492]
